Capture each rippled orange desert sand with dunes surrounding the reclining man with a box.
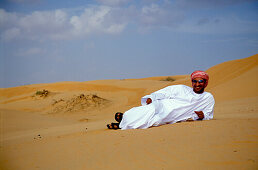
[0,55,258,170]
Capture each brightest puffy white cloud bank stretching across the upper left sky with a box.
[0,6,127,41]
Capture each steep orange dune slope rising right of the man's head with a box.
[207,54,258,101]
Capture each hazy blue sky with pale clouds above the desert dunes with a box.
[0,0,258,88]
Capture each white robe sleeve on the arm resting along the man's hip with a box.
[141,86,175,105]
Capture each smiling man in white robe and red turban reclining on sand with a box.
[107,71,215,130]
